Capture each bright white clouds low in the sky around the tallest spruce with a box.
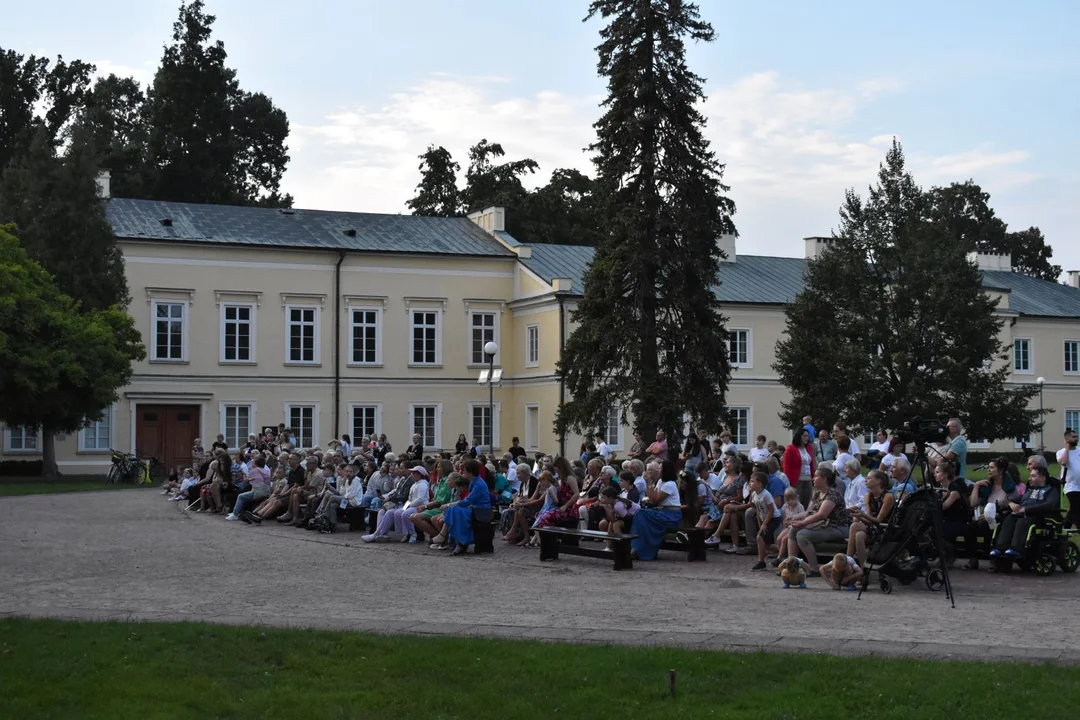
[284,72,1036,255]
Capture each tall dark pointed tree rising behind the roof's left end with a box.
[143,0,293,206]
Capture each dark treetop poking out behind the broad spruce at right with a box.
[929,180,1062,282]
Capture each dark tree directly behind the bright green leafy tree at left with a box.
[0,125,129,310]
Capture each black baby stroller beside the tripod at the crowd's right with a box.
[863,486,946,595]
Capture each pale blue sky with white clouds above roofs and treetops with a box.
[4,0,1080,270]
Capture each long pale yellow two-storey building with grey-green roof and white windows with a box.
[2,193,1080,474]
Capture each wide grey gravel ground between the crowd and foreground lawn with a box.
[0,490,1080,664]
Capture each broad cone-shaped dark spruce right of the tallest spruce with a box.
[773,140,1038,440]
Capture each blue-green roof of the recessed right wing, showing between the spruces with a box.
[522,243,1080,318]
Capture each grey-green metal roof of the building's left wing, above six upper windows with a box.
[106,198,514,257]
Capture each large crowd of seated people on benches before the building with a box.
[157,419,1080,578]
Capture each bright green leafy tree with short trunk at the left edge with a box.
[0,226,146,477]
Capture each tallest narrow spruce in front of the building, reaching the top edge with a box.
[556,0,734,444]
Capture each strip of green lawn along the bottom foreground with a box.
[0,610,1080,720]
